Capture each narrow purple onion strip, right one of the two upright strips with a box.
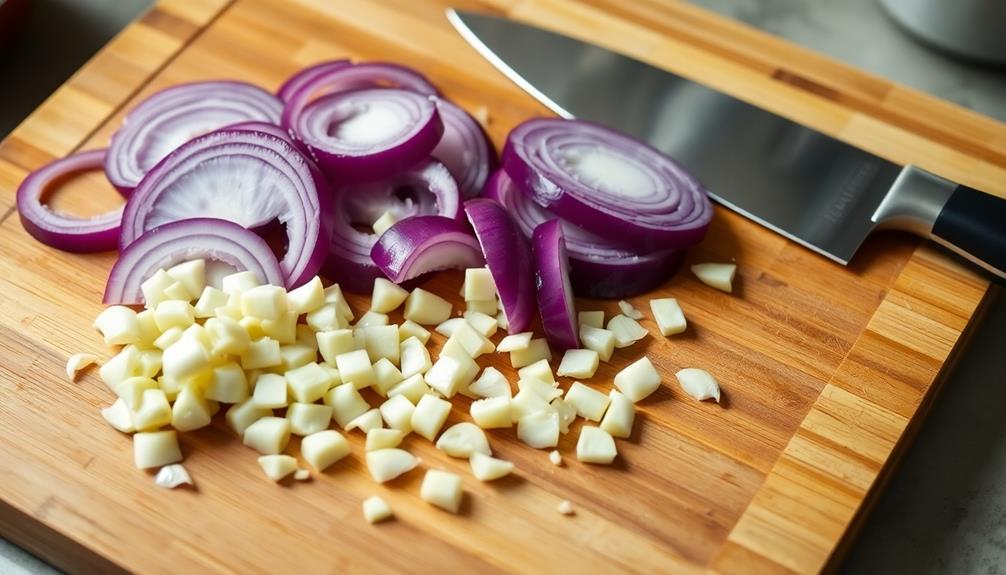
[531,219,579,350]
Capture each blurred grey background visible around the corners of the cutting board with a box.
[0,0,1006,575]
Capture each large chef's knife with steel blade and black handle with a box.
[448,10,1006,278]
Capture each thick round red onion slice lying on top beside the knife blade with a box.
[503,118,712,251]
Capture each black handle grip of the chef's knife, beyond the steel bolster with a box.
[932,186,1006,282]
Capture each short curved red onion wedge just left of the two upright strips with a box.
[370,216,486,283]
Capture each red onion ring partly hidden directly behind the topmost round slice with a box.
[281,60,439,128]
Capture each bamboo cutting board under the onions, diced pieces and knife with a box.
[0,0,1006,573]
